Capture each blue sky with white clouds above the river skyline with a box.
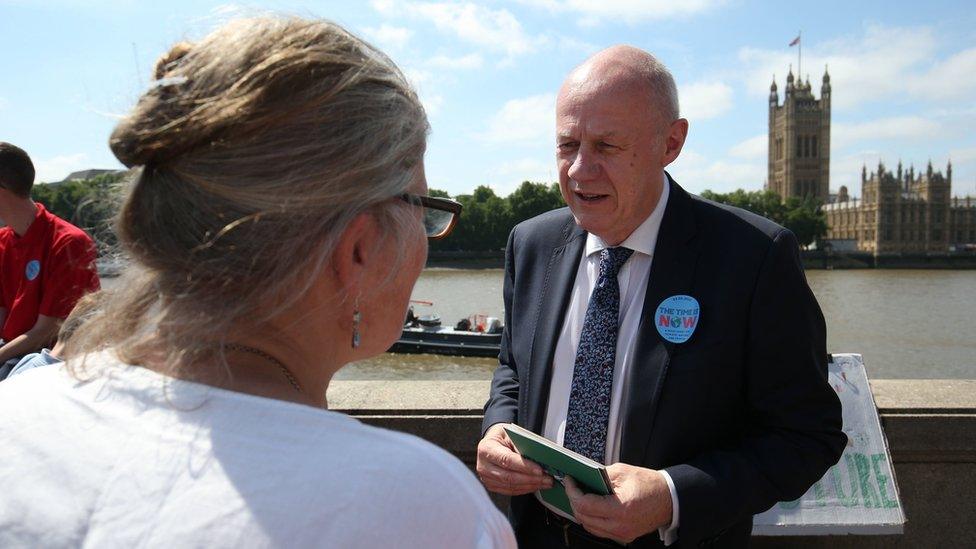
[0,0,976,195]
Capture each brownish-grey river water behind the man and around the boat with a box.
[337,268,976,379]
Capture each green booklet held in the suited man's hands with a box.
[502,423,613,522]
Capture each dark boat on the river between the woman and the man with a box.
[387,308,502,357]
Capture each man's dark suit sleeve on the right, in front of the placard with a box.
[666,229,847,543]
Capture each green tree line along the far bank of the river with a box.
[33,174,827,252]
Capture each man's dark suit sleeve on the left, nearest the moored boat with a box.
[481,227,519,436]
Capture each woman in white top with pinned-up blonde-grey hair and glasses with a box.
[0,18,514,547]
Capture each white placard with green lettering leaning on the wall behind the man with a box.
[752,354,905,536]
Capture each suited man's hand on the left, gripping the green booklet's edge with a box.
[477,423,552,496]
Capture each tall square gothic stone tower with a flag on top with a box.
[766,69,830,204]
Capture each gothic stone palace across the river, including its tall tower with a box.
[766,70,976,255]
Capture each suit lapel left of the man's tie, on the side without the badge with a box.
[520,219,586,433]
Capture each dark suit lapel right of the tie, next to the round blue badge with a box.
[620,175,701,464]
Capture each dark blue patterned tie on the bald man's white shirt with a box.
[563,247,634,463]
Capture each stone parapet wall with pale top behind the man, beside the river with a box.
[328,380,976,549]
